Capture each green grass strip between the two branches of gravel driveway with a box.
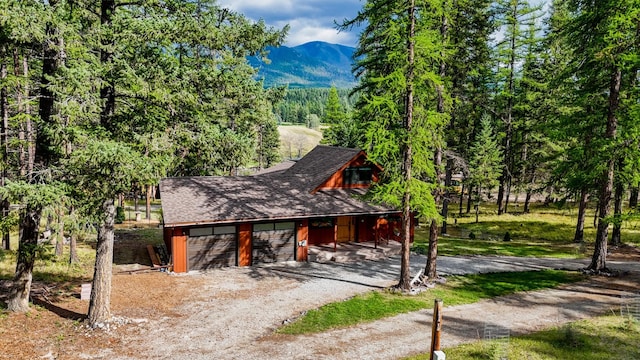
[278,270,583,334]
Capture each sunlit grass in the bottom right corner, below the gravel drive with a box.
[408,315,640,360]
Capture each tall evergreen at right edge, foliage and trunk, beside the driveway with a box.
[565,0,640,272]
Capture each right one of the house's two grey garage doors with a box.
[253,222,296,264]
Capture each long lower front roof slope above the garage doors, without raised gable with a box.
[160,176,395,226]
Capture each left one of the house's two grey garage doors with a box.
[187,226,237,270]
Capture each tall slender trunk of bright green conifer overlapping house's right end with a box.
[398,0,415,290]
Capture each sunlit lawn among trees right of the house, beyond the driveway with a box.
[413,205,640,258]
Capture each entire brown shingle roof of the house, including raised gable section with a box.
[160,146,396,227]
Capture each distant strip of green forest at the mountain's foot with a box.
[273,88,358,127]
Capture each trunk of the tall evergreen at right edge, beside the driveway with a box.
[588,66,622,272]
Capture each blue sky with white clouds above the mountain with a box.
[218,0,365,46]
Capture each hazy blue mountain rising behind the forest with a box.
[249,41,356,88]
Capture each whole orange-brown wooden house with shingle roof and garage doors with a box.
[160,146,410,272]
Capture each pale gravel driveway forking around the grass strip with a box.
[75,256,640,360]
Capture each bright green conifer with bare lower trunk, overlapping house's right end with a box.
[342,0,447,289]
